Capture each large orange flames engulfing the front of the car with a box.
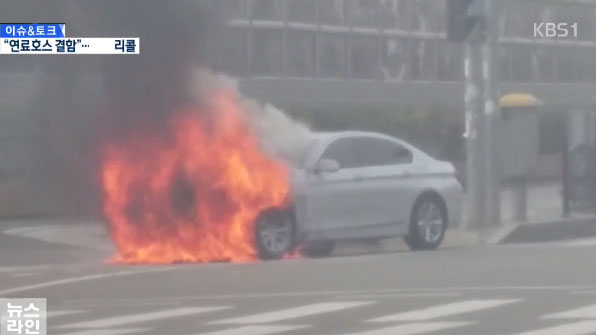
[102,90,289,264]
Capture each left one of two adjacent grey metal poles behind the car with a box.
[464,33,486,228]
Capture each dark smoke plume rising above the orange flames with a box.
[96,0,218,136]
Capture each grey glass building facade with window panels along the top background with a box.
[212,0,596,83]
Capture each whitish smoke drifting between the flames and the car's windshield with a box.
[191,70,312,164]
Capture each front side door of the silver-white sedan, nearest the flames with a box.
[307,137,370,238]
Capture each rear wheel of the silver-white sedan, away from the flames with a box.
[404,194,447,250]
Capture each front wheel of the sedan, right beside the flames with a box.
[255,209,294,260]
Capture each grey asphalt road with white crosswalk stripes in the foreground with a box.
[0,223,596,335]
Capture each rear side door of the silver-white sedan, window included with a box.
[354,136,415,234]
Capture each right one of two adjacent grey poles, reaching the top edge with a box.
[482,0,501,225]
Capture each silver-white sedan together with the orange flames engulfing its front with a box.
[101,85,462,264]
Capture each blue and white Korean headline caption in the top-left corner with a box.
[0,23,140,55]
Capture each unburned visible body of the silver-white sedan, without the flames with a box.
[255,131,463,259]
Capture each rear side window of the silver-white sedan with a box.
[354,137,413,166]
